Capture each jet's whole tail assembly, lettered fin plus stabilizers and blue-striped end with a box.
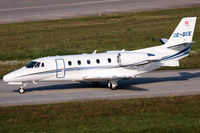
[160,17,197,66]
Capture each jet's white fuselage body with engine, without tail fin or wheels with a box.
[4,45,186,83]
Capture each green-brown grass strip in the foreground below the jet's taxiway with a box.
[0,95,200,133]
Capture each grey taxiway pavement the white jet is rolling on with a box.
[0,69,200,106]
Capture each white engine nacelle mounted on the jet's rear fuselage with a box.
[117,52,148,66]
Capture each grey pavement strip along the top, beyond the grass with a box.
[0,0,200,24]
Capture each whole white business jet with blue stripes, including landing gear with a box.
[3,17,196,94]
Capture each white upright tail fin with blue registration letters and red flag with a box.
[165,17,196,47]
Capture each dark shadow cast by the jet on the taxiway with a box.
[14,72,200,92]
